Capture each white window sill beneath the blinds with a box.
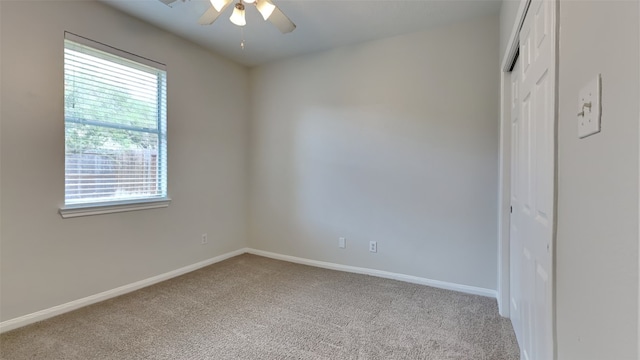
[59,198,171,219]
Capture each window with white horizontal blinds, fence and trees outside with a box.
[61,33,168,217]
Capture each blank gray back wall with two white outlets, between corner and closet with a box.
[249,16,499,289]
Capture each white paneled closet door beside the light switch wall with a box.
[511,0,556,360]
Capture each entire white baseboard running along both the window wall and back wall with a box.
[0,248,498,333]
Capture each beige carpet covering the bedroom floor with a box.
[0,255,519,360]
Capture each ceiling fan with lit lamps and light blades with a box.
[160,0,296,34]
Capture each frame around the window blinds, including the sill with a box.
[59,31,171,218]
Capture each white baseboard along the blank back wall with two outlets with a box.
[245,249,498,299]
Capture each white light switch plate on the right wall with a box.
[578,74,601,139]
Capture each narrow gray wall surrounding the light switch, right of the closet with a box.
[556,1,640,360]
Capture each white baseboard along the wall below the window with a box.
[0,249,247,333]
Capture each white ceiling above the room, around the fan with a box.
[100,0,501,66]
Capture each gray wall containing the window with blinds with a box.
[0,1,248,320]
